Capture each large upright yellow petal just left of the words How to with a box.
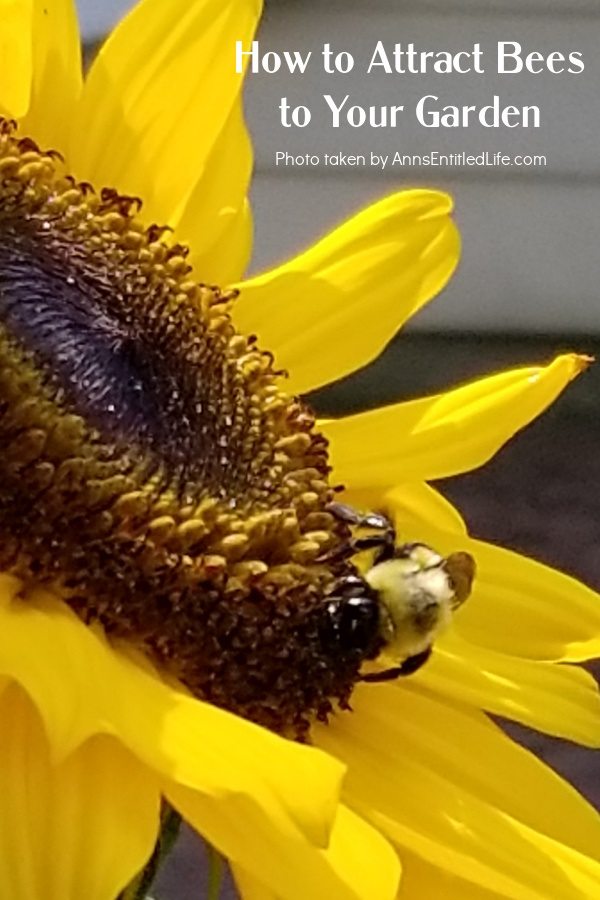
[69,0,261,239]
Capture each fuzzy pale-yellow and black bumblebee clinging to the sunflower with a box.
[327,503,475,682]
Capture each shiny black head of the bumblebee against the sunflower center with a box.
[327,594,381,659]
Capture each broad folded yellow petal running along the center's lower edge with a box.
[0,575,343,856]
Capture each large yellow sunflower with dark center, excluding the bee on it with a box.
[0,0,600,900]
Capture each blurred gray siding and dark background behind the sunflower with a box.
[78,0,600,900]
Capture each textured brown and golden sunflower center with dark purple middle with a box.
[0,121,368,734]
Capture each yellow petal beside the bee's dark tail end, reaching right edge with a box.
[384,486,600,662]
